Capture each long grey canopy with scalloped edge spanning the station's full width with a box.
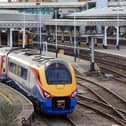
[0,9,126,28]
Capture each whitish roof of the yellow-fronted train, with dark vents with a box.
[0,47,59,68]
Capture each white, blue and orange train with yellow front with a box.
[0,47,77,115]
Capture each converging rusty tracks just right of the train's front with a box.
[77,76,126,126]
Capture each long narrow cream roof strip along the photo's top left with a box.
[0,1,88,9]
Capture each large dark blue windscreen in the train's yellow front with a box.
[46,64,72,85]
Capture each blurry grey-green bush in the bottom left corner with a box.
[0,102,17,126]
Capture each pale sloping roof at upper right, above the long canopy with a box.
[67,6,126,19]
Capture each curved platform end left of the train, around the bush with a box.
[0,82,34,126]
